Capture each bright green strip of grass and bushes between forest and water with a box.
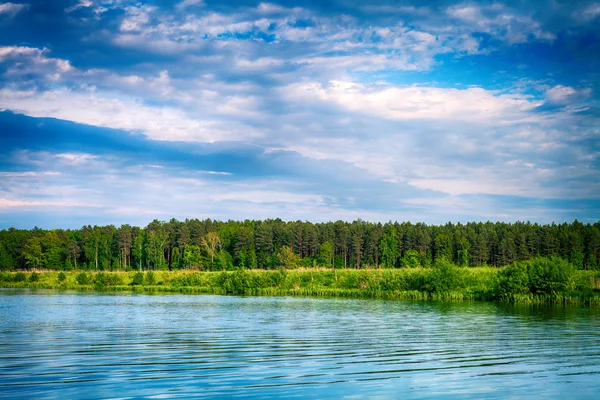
[0,266,600,304]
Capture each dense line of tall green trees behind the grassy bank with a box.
[0,219,600,271]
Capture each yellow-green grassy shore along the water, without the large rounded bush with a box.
[0,267,600,305]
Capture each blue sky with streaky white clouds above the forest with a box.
[0,0,600,229]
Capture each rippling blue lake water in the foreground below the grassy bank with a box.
[0,289,600,399]
